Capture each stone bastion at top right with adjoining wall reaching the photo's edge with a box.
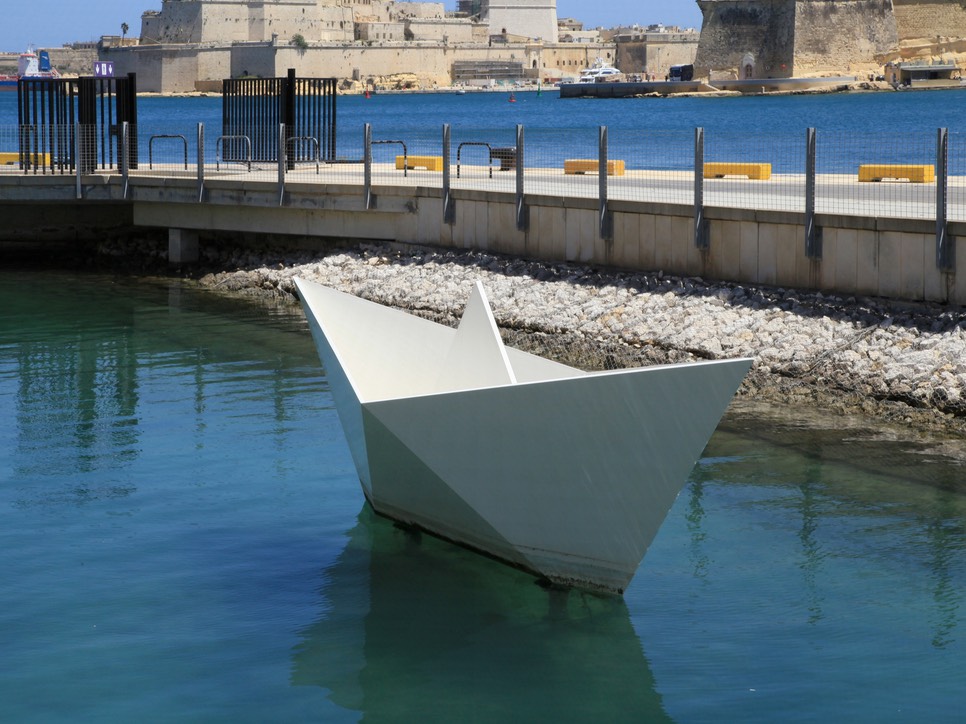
[695,0,966,79]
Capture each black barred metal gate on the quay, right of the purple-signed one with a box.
[222,68,337,168]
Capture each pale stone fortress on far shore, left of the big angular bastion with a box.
[100,0,697,93]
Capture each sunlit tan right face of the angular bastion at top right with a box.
[793,0,899,76]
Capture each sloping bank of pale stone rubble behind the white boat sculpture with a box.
[195,245,966,430]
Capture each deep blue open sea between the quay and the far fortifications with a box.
[0,84,966,176]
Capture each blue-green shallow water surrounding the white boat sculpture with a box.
[0,272,966,722]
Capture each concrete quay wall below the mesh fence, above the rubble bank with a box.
[0,176,966,305]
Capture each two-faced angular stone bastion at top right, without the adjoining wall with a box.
[695,0,899,79]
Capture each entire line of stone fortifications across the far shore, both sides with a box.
[87,0,966,93]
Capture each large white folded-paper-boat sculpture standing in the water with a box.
[297,279,751,593]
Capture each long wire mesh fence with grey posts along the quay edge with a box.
[0,123,966,230]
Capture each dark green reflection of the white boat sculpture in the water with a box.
[292,505,670,722]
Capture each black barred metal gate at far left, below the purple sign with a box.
[17,73,138,173]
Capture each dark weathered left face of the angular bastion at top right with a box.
[694,0,795,78]
